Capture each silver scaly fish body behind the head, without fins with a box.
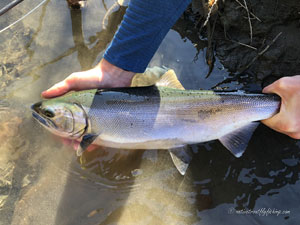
[87,86,279,149]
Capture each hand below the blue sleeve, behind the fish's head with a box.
[42,59,135,98]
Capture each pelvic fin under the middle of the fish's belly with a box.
[169,146,192,175]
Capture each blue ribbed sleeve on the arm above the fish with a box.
[104,0,191,73]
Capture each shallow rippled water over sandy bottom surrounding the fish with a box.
[0,0,300,225]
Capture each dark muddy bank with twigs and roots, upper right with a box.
[188,0,300,89]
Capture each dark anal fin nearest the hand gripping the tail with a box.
[219,122,259,157]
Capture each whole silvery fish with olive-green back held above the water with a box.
[31,70,281,175]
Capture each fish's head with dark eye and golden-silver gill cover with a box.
[31,100,88,139]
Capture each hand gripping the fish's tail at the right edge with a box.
[262,75,300,139]
